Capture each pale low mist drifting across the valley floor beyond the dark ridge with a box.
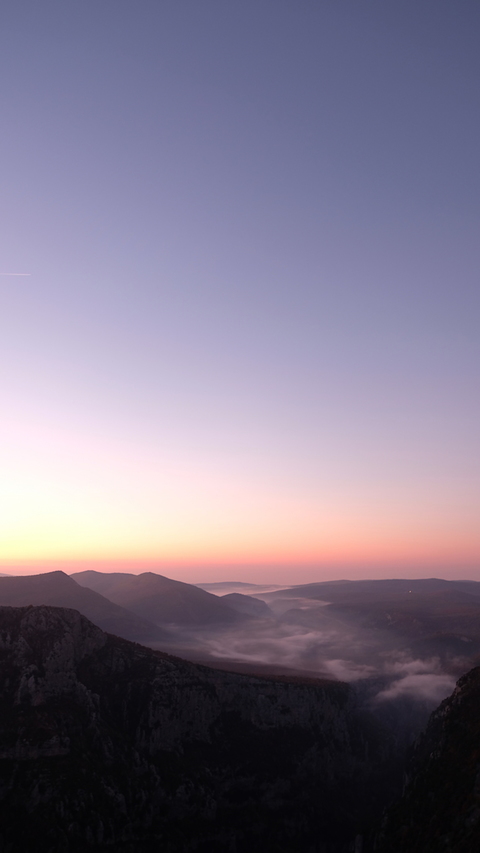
[155,588,480,733]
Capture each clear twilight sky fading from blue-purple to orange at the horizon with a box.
[0,0,480,583]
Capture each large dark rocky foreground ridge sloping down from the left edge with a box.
[0,606,394,853]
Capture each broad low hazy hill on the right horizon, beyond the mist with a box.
[259,578,480,684]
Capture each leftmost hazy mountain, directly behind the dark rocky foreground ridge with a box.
[0,572,167,643]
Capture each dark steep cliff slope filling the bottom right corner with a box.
[375,667,480,853]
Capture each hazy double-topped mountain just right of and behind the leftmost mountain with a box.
[71,571,241,625]
